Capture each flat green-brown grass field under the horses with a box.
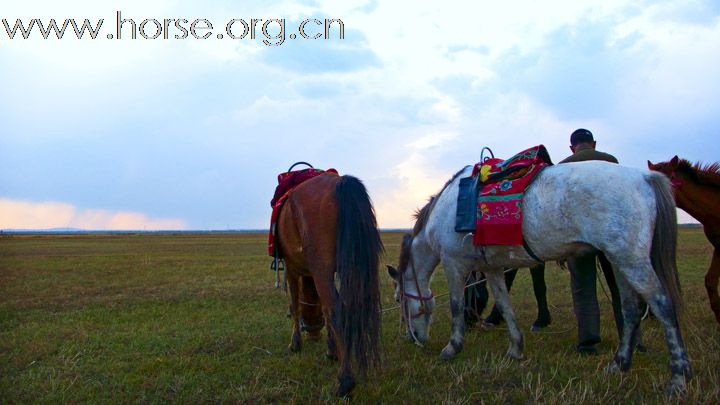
[0,229,720,404]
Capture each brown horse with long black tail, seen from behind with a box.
[278,172,383,396]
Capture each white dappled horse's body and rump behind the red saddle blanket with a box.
[523,161,656,256]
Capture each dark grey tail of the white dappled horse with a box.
[647,172,682,316]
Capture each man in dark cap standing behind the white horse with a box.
[560,128,623,354]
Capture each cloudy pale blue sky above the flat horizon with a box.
[0,0,720,230]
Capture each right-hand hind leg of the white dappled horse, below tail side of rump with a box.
[619,259,692,393]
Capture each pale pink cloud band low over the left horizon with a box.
[0,198,187,230]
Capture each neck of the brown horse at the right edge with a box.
[675,176,720,227]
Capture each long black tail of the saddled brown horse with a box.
[335,176,384,376]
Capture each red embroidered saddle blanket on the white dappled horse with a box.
[473,145,552,245]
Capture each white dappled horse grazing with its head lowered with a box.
[388,161,692,392]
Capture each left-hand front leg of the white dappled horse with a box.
[440,260,465,360]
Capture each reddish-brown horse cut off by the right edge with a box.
[648,156,720,324]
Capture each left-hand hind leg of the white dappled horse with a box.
[606,270,642,373]
